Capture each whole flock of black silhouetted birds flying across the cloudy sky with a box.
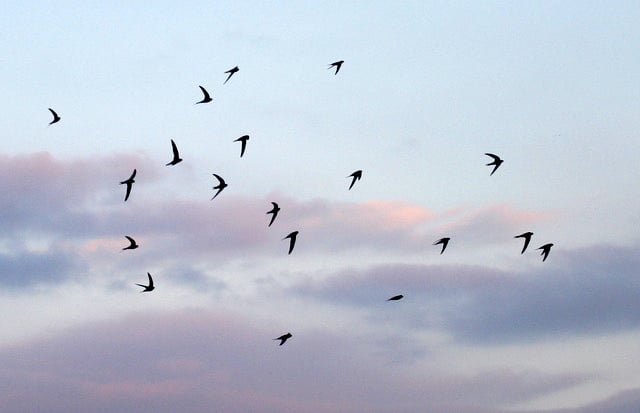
[49,60,553,345]
